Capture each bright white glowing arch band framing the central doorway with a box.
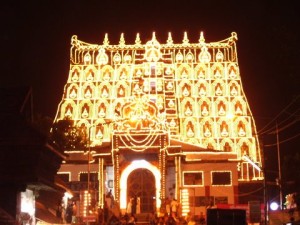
[120,160,161,212]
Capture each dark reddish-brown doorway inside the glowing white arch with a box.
[127,169,156,213]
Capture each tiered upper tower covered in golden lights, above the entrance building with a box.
[55,32,262,180]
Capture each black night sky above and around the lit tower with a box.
[0,0,300,188]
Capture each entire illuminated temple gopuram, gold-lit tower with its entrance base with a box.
[55,32,264,216]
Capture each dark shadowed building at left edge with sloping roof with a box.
[0,87,67,225]
